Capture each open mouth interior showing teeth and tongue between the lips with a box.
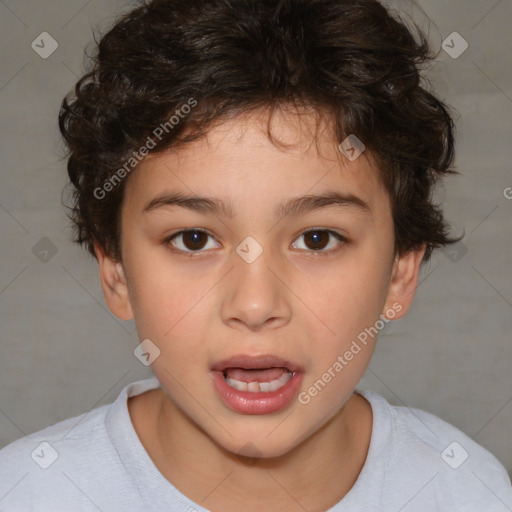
[222,367,294,393]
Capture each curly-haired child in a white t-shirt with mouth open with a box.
[0,0,512,512]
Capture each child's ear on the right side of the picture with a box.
[382,244,426,320]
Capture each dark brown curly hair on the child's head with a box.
[59,0,462,263]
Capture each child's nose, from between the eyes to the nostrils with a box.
[221,244,291,332]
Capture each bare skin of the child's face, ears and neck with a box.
[96,106,425,512]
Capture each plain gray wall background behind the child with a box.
[0,0,512,480]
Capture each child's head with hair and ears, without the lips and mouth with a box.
[59,0,457,457]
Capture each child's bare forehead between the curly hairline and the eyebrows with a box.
[124,110,389,218]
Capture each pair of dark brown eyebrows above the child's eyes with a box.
[143,191,373,218]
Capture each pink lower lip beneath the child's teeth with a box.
[211,371,302,414]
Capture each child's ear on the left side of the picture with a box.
[94,243,133,320]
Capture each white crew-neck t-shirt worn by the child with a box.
[0,377,512,512]
